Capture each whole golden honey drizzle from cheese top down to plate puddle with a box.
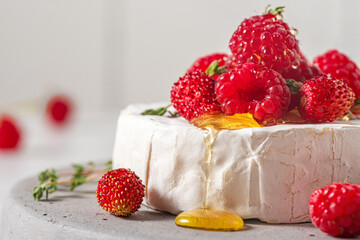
[175,113,260,231]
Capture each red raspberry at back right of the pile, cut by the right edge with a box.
[313,50,360,98]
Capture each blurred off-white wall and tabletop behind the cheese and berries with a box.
[0,0,360,231]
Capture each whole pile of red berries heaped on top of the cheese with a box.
[171,8,360,125]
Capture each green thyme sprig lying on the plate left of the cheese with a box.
[33,161,112,201]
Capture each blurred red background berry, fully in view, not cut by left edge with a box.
[46,95,73,125]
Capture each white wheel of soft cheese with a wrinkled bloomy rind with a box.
[113,104,360,223]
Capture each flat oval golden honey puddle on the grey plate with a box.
[175,208,244,231]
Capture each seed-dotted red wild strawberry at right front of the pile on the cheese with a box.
[298,76,355,122]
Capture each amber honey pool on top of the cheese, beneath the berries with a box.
[191,113,261,131]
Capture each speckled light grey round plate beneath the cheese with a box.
[0,172,358,240]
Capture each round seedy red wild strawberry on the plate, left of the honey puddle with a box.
[96,168,145,217]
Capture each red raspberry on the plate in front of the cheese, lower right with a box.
[309,183,360,237]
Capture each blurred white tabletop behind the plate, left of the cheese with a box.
[0,111,119,229]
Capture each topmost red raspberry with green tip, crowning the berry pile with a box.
[229,8,300,73]
